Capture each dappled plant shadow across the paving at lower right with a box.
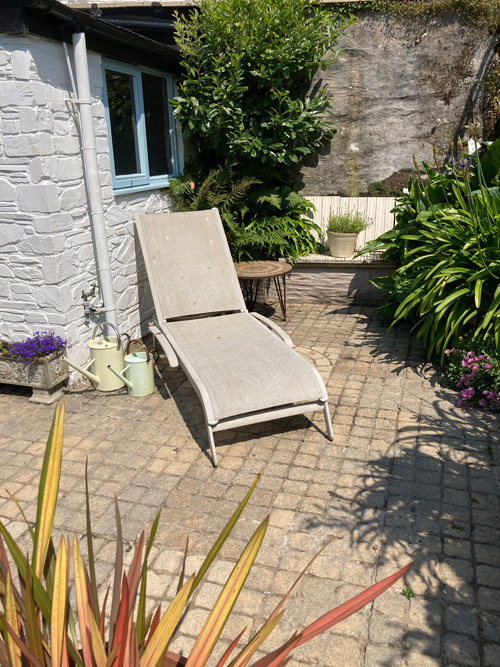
[300,401,500,667]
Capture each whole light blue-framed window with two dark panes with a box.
[103,60,179,193]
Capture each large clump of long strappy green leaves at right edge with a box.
[360,130,500,361]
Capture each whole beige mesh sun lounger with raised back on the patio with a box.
[136,209,333,466]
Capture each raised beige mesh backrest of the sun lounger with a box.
[136,208,245,321]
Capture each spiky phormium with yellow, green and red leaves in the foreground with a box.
[0,405,411,667]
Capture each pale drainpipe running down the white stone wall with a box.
[73,32,118,327]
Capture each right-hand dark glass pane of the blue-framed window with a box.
[142,74,173,176]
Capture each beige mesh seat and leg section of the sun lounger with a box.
[166,313,323,419]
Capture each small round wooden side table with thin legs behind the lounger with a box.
[234,260,293,322]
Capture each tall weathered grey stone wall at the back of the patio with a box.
[301,10,498,197]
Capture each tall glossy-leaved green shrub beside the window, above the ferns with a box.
[172,0,347,174]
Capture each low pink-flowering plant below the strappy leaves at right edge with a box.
[444,336,500,412]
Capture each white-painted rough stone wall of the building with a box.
[0,35,177,374]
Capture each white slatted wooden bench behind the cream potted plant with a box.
[299,197,395,264]
